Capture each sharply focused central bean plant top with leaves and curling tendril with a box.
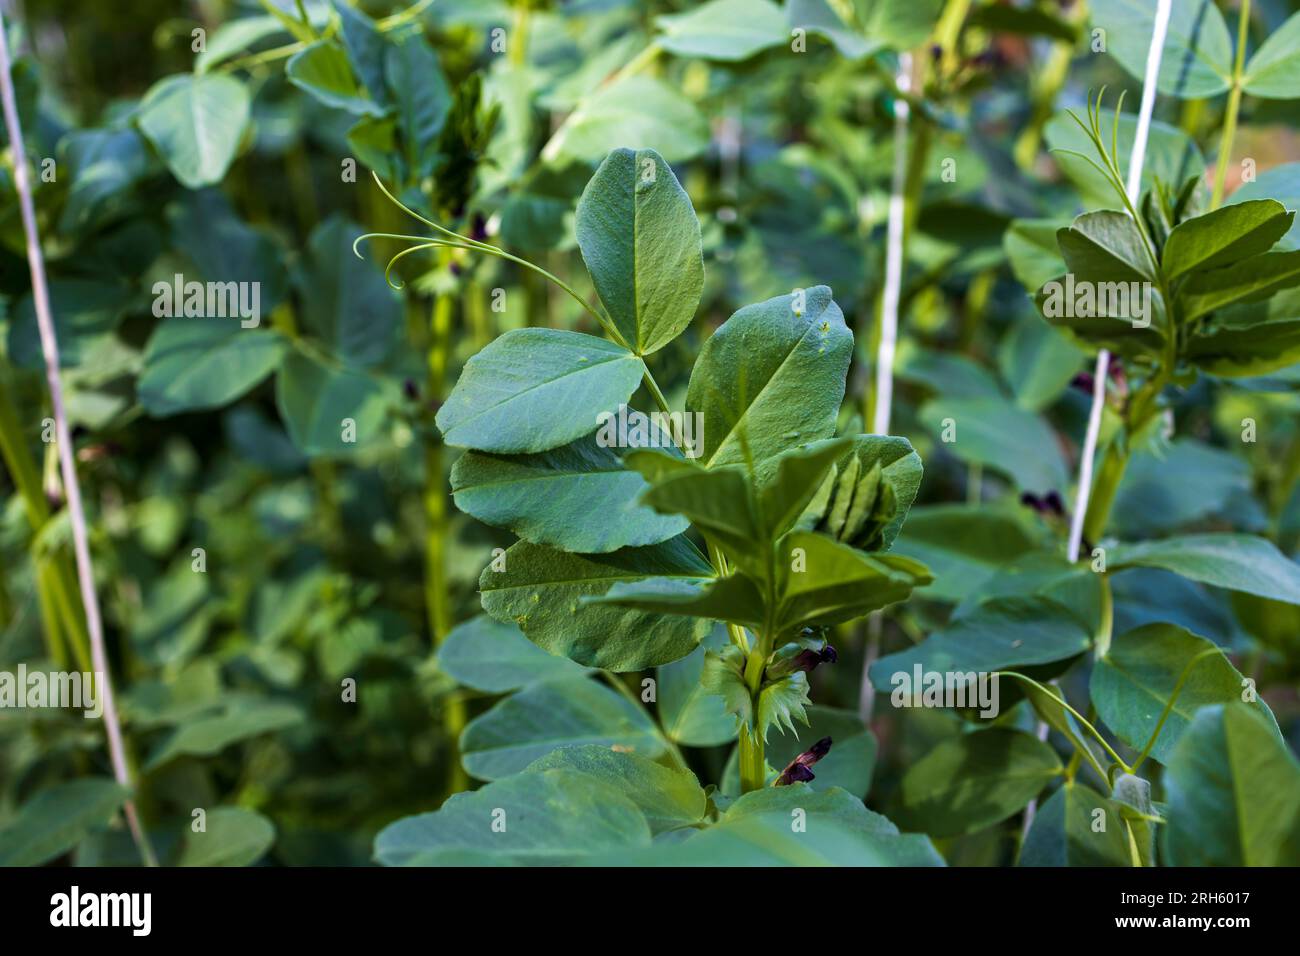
[363,150,946,858]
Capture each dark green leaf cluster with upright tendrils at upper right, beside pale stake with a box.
[1037,90,1300,390]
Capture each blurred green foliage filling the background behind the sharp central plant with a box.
[0,0,1300,864]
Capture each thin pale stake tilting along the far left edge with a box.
[0,16,157,866]
